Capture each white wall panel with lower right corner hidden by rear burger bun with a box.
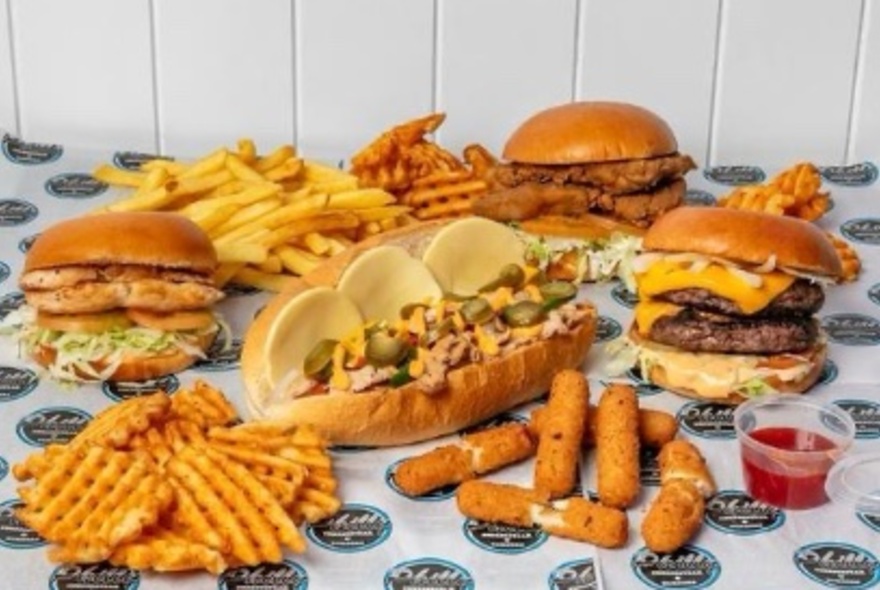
[437,0,577,160]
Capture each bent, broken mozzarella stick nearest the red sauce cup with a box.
[642,439,716,553]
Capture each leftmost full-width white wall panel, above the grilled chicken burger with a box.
[6,0,155,154]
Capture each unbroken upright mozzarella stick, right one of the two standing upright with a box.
[596,384,639,508]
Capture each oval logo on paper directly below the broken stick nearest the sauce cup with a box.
[630,545,721,590]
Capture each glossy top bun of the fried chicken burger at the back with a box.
[503,102,678,165]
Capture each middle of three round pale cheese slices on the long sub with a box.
[336,246,443,322]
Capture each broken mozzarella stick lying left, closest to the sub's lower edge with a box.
[394,423,535,496]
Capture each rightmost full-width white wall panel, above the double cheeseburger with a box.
[712,0,862,165]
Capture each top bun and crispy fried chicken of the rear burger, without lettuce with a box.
[473,102,696,237]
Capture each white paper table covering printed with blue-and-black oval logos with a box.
[0,135,880,590]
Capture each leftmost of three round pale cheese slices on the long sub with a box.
[265,287,364,387]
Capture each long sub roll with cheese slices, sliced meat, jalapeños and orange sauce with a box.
[242,218,596,446]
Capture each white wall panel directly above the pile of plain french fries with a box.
[153,0,295,154]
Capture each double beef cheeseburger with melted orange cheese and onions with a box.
[612,207,841,403]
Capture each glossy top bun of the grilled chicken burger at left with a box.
[24,212,217,274]
